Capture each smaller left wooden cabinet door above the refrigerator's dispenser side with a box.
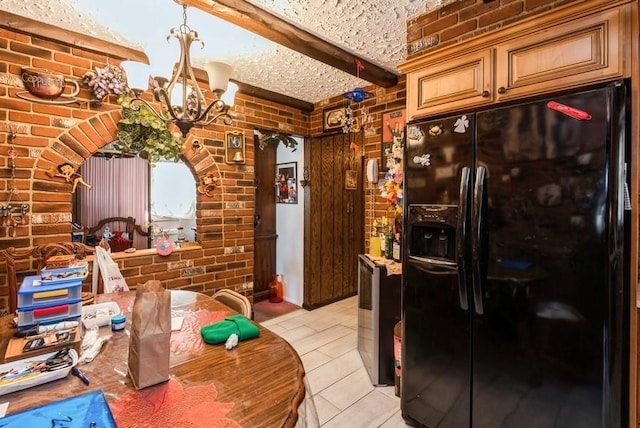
[407,49,493,119]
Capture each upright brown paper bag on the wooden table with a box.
[129,281,171,389]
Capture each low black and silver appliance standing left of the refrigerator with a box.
[358,254,402,385]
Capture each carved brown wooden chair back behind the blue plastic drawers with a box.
[0,242,93,314]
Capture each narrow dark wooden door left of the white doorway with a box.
[253,138,278,302]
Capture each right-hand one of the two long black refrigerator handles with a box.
[471,166,487,315]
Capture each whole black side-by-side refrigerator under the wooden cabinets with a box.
[401,81,630,428]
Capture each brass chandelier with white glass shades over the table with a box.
[121,0,238,137]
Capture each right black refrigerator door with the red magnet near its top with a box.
[471,88,619,428]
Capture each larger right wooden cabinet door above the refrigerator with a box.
[496,9,624,101]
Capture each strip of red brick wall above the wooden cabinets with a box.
[407,0,579,59]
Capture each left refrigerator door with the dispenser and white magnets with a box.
[401,112,473,427]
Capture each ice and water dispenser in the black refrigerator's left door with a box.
[408,205,458,263]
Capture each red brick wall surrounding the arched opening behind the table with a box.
[0,24,309,307]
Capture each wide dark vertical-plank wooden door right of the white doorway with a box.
[303,130,364,309]
